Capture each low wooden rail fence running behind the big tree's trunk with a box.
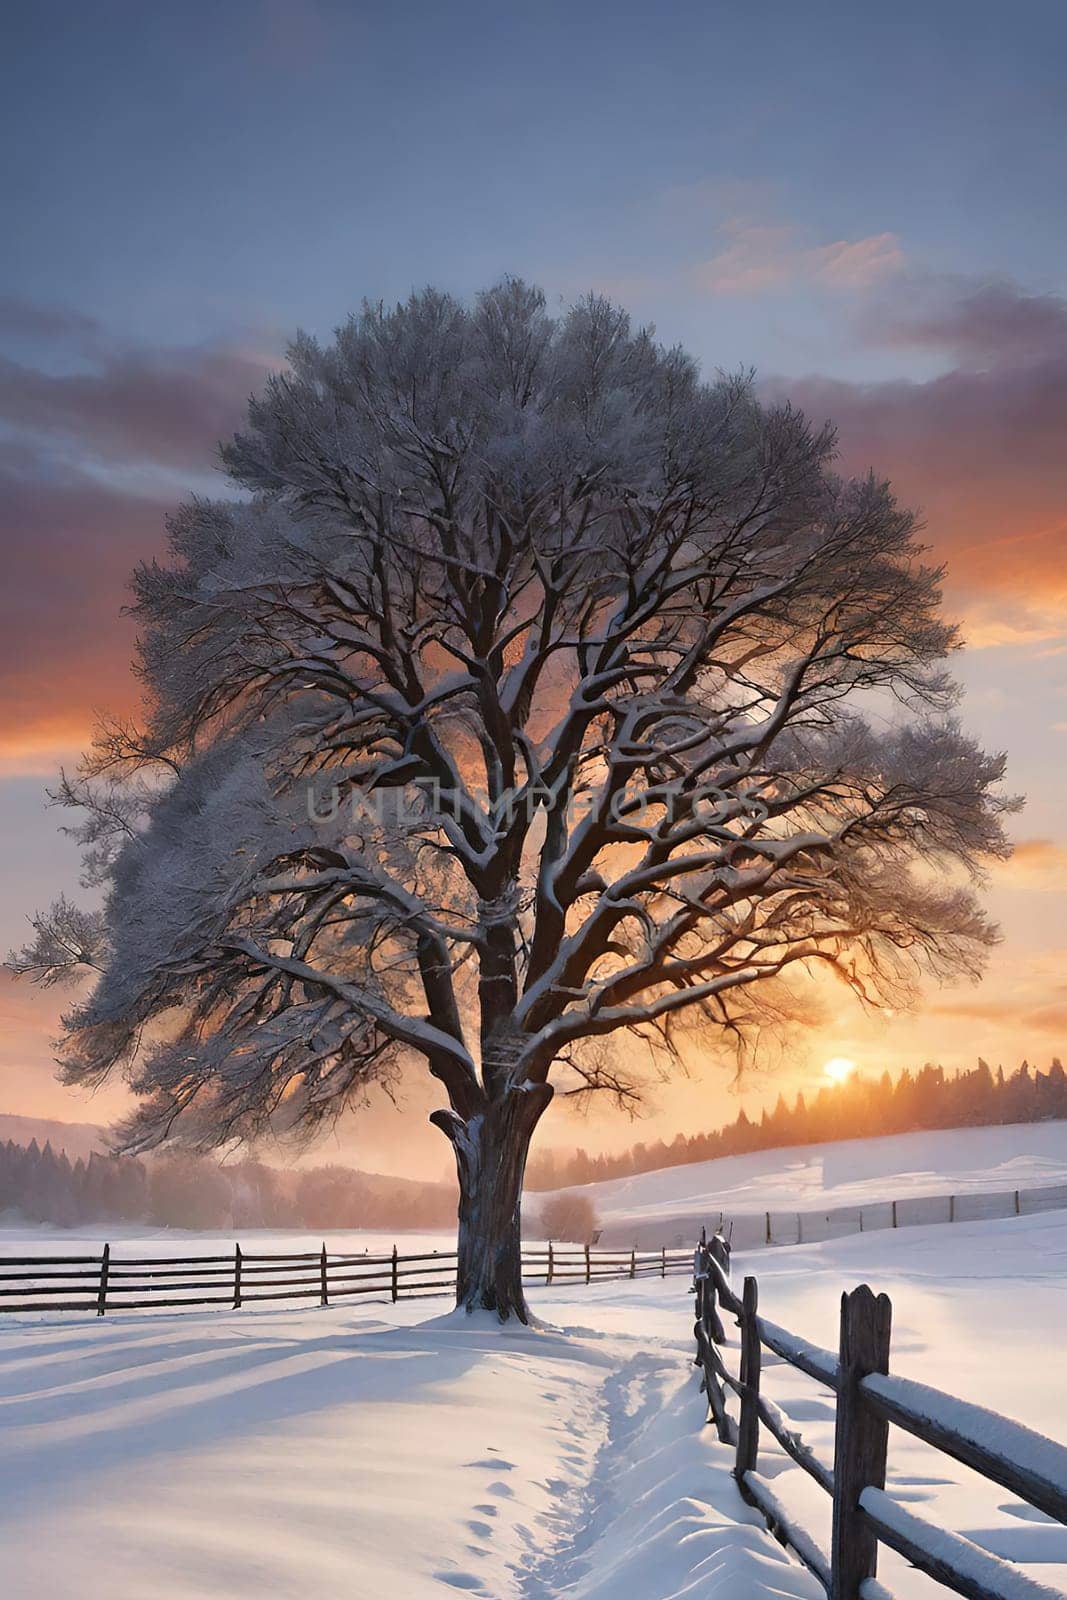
[0,1243,693,1317]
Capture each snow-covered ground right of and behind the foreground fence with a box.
[733,1211,1067,1600]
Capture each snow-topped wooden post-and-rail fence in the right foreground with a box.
[696,1235,1067,1600]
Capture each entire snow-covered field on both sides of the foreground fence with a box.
[0,1213,1067,1600]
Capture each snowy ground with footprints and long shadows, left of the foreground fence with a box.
[0,1280,813,1600]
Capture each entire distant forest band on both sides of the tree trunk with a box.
[0,1061,1067,1232]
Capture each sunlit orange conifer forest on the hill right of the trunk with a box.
[526,1059,1067,1189]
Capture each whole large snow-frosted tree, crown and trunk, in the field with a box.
[16,280,1008,1318]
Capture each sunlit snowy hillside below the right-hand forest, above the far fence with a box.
[550,1122,1067,1245]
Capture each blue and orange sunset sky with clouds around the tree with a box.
[0,0,1067,1165]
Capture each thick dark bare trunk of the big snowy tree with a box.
[430,1083,552,1322]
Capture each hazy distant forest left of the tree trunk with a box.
[0,1139,456,1230]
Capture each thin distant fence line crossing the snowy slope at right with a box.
[620,1184,1067,1250]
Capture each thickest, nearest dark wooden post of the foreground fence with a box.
[829,1283,893,1600]
